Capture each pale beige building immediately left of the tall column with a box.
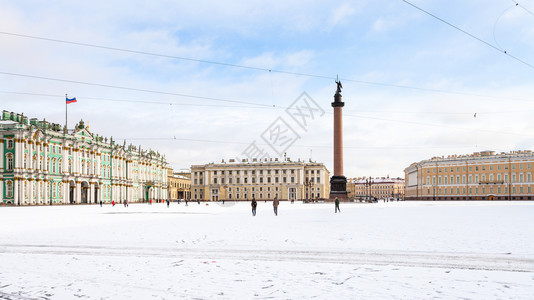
[191,158,330,201]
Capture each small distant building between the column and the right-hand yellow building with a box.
[347,176,405,200]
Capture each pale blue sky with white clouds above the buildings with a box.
[0,0,534,177]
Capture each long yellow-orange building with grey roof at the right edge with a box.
[404,150,534,200]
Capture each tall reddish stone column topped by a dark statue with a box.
[330,80,347,201]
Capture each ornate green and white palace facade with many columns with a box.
[0,111,167,205]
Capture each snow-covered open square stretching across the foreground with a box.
[0,202,534,299]
